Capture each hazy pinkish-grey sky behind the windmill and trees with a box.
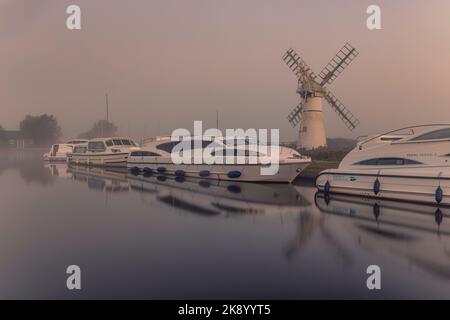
[0,0,450,140]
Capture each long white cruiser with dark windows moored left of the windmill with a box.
[127,136,311,183]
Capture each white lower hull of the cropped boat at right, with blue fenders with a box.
[316,169,450,205]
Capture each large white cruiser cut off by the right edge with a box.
[316,124,450,205]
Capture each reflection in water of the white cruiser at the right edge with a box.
[315,192,450,280]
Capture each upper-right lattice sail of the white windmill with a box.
[319,43,358,86]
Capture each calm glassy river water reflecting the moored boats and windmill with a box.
[0,151,450,299]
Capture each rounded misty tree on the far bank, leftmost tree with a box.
[20,114,61,146]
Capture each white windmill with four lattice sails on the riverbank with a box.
[283,43,359,150]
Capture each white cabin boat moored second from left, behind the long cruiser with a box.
[67,137,139,167]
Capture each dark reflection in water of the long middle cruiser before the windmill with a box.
[129,175,309,215]
